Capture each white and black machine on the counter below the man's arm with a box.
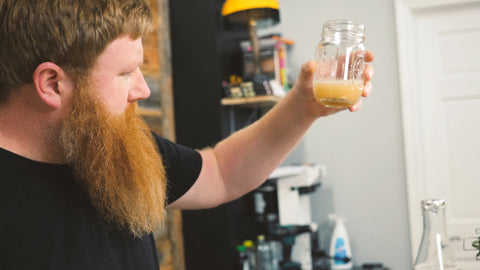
[253,164,326,270]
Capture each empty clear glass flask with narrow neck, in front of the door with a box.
[414,199,460,270]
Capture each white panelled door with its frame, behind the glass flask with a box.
[396,0,480,270]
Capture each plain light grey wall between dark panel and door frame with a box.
[260,0,412,270]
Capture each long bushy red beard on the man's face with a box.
[60,80,166,236]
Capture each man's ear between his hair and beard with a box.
[33,62,73,109]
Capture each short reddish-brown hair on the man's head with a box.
[0,0,153,104]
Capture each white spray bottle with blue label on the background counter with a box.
[329,215,353,270]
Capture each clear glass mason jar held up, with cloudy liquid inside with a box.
[313,20,366,108]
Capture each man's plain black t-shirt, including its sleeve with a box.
[0,136,202,270]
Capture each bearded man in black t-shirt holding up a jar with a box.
[0,0,373,270]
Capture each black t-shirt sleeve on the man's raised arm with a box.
[152,133,202,205]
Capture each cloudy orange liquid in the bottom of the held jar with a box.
[313,80,363,108]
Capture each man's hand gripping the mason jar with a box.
[292,50,374,117]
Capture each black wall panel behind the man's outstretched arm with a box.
[169,0,264,270]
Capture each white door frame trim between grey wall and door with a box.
[394,0,480,260]
